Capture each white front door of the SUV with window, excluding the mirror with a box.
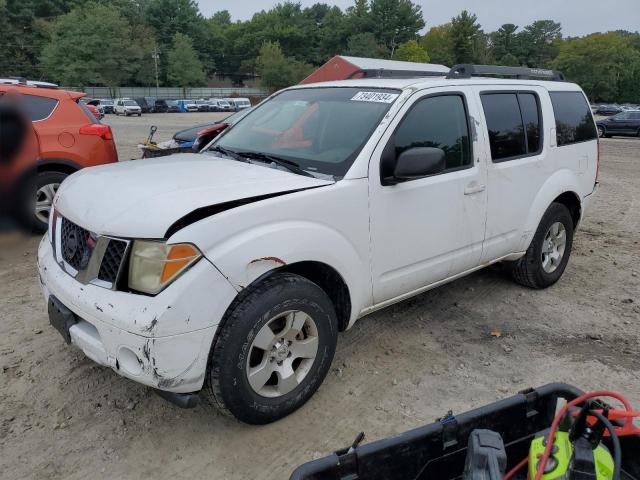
[369,88,487,303]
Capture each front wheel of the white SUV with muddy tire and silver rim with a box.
[203,273,338,424]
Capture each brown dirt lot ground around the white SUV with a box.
[0,114,640,479]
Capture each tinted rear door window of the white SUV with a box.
[481,92,542,163]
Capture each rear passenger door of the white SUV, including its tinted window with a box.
[474,87,555,263]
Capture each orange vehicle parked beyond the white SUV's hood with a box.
[0,80,118,232]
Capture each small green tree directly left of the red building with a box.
[256,42,313,92]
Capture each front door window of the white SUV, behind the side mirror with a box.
[395,95,471,169]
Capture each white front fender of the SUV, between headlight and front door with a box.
[169,179,373,322]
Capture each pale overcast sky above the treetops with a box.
[198,0,640,36]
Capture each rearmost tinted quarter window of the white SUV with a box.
[549,92,597,147]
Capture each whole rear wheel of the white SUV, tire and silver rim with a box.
[510,203,573,288]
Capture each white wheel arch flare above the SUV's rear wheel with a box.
[519,169,582,252]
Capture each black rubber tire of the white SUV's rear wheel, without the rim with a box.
[509,203,573,288]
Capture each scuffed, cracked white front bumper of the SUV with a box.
[38,237,237,393]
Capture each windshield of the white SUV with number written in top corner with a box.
[211,87,400,179]
